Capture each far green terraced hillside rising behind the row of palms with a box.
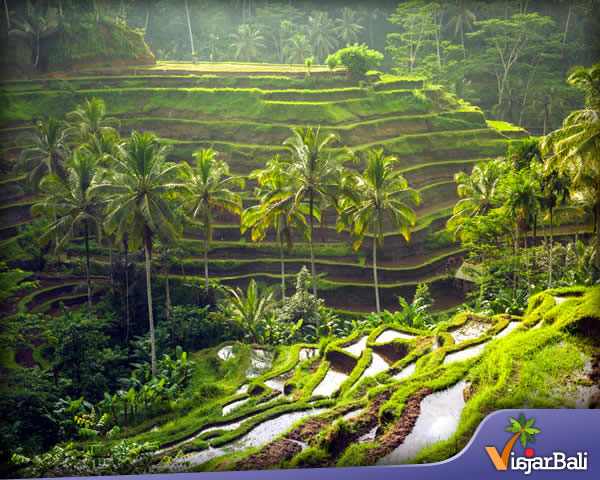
[0,63,568,312]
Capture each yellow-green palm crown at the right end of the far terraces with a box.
[446,159,506,238]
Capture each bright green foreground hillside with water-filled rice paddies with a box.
[9,287,600,476]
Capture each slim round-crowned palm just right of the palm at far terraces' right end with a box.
[498,169,540,292]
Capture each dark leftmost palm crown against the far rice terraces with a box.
[16,117,69,187]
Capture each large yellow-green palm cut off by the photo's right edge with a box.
[541,63,600,268]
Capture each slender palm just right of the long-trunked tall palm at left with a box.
[183,148,244,293]
